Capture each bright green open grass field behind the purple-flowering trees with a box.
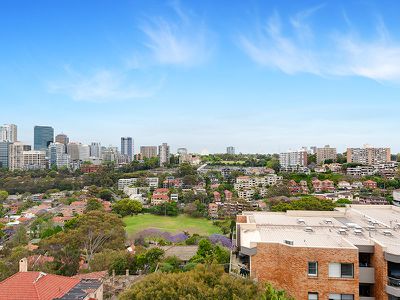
[124,214,221,236]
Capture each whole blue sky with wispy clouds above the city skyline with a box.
[0,0,400,153]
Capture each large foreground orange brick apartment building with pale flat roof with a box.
[234,205,400,300]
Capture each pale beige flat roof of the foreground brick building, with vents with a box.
[238,205,400,255]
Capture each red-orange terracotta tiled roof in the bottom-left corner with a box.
[0,272,80,300]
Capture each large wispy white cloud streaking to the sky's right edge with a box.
[238,5,400,83]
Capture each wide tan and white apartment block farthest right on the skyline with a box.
[347,145,390,165]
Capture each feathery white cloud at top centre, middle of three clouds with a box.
[140,2,213,66]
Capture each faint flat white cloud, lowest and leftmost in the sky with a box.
[48,66,163,102]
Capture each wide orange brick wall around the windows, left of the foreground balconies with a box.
[250,243,360,300]
